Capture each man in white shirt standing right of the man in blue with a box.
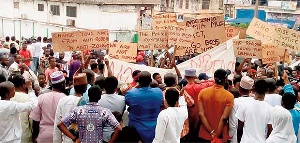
[153,88,188,143]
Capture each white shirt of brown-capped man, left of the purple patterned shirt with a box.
[53,95,81,143]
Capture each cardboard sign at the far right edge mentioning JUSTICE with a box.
[274,27,300,52]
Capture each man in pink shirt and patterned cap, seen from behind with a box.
[30,71,66,143]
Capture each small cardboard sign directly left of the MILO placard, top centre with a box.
[152,13,177,30]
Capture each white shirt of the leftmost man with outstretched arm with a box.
[0,92,38,143]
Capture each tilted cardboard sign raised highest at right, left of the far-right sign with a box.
[246,18,275,44]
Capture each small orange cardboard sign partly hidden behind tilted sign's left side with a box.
[225,26,246,40]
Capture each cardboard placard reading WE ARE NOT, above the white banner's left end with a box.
[108,42,137,63]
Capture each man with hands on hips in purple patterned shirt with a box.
[57,86,122,143]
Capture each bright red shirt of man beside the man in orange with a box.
[185,80,214,129]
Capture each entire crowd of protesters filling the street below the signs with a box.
[0,37,300,143]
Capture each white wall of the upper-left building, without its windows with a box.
[0,0,139,42]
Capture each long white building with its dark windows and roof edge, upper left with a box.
[0,0,159,42]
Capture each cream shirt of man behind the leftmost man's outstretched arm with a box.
[10,92,32,143]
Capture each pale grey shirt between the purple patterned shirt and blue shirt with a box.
[98,94,125,142]
